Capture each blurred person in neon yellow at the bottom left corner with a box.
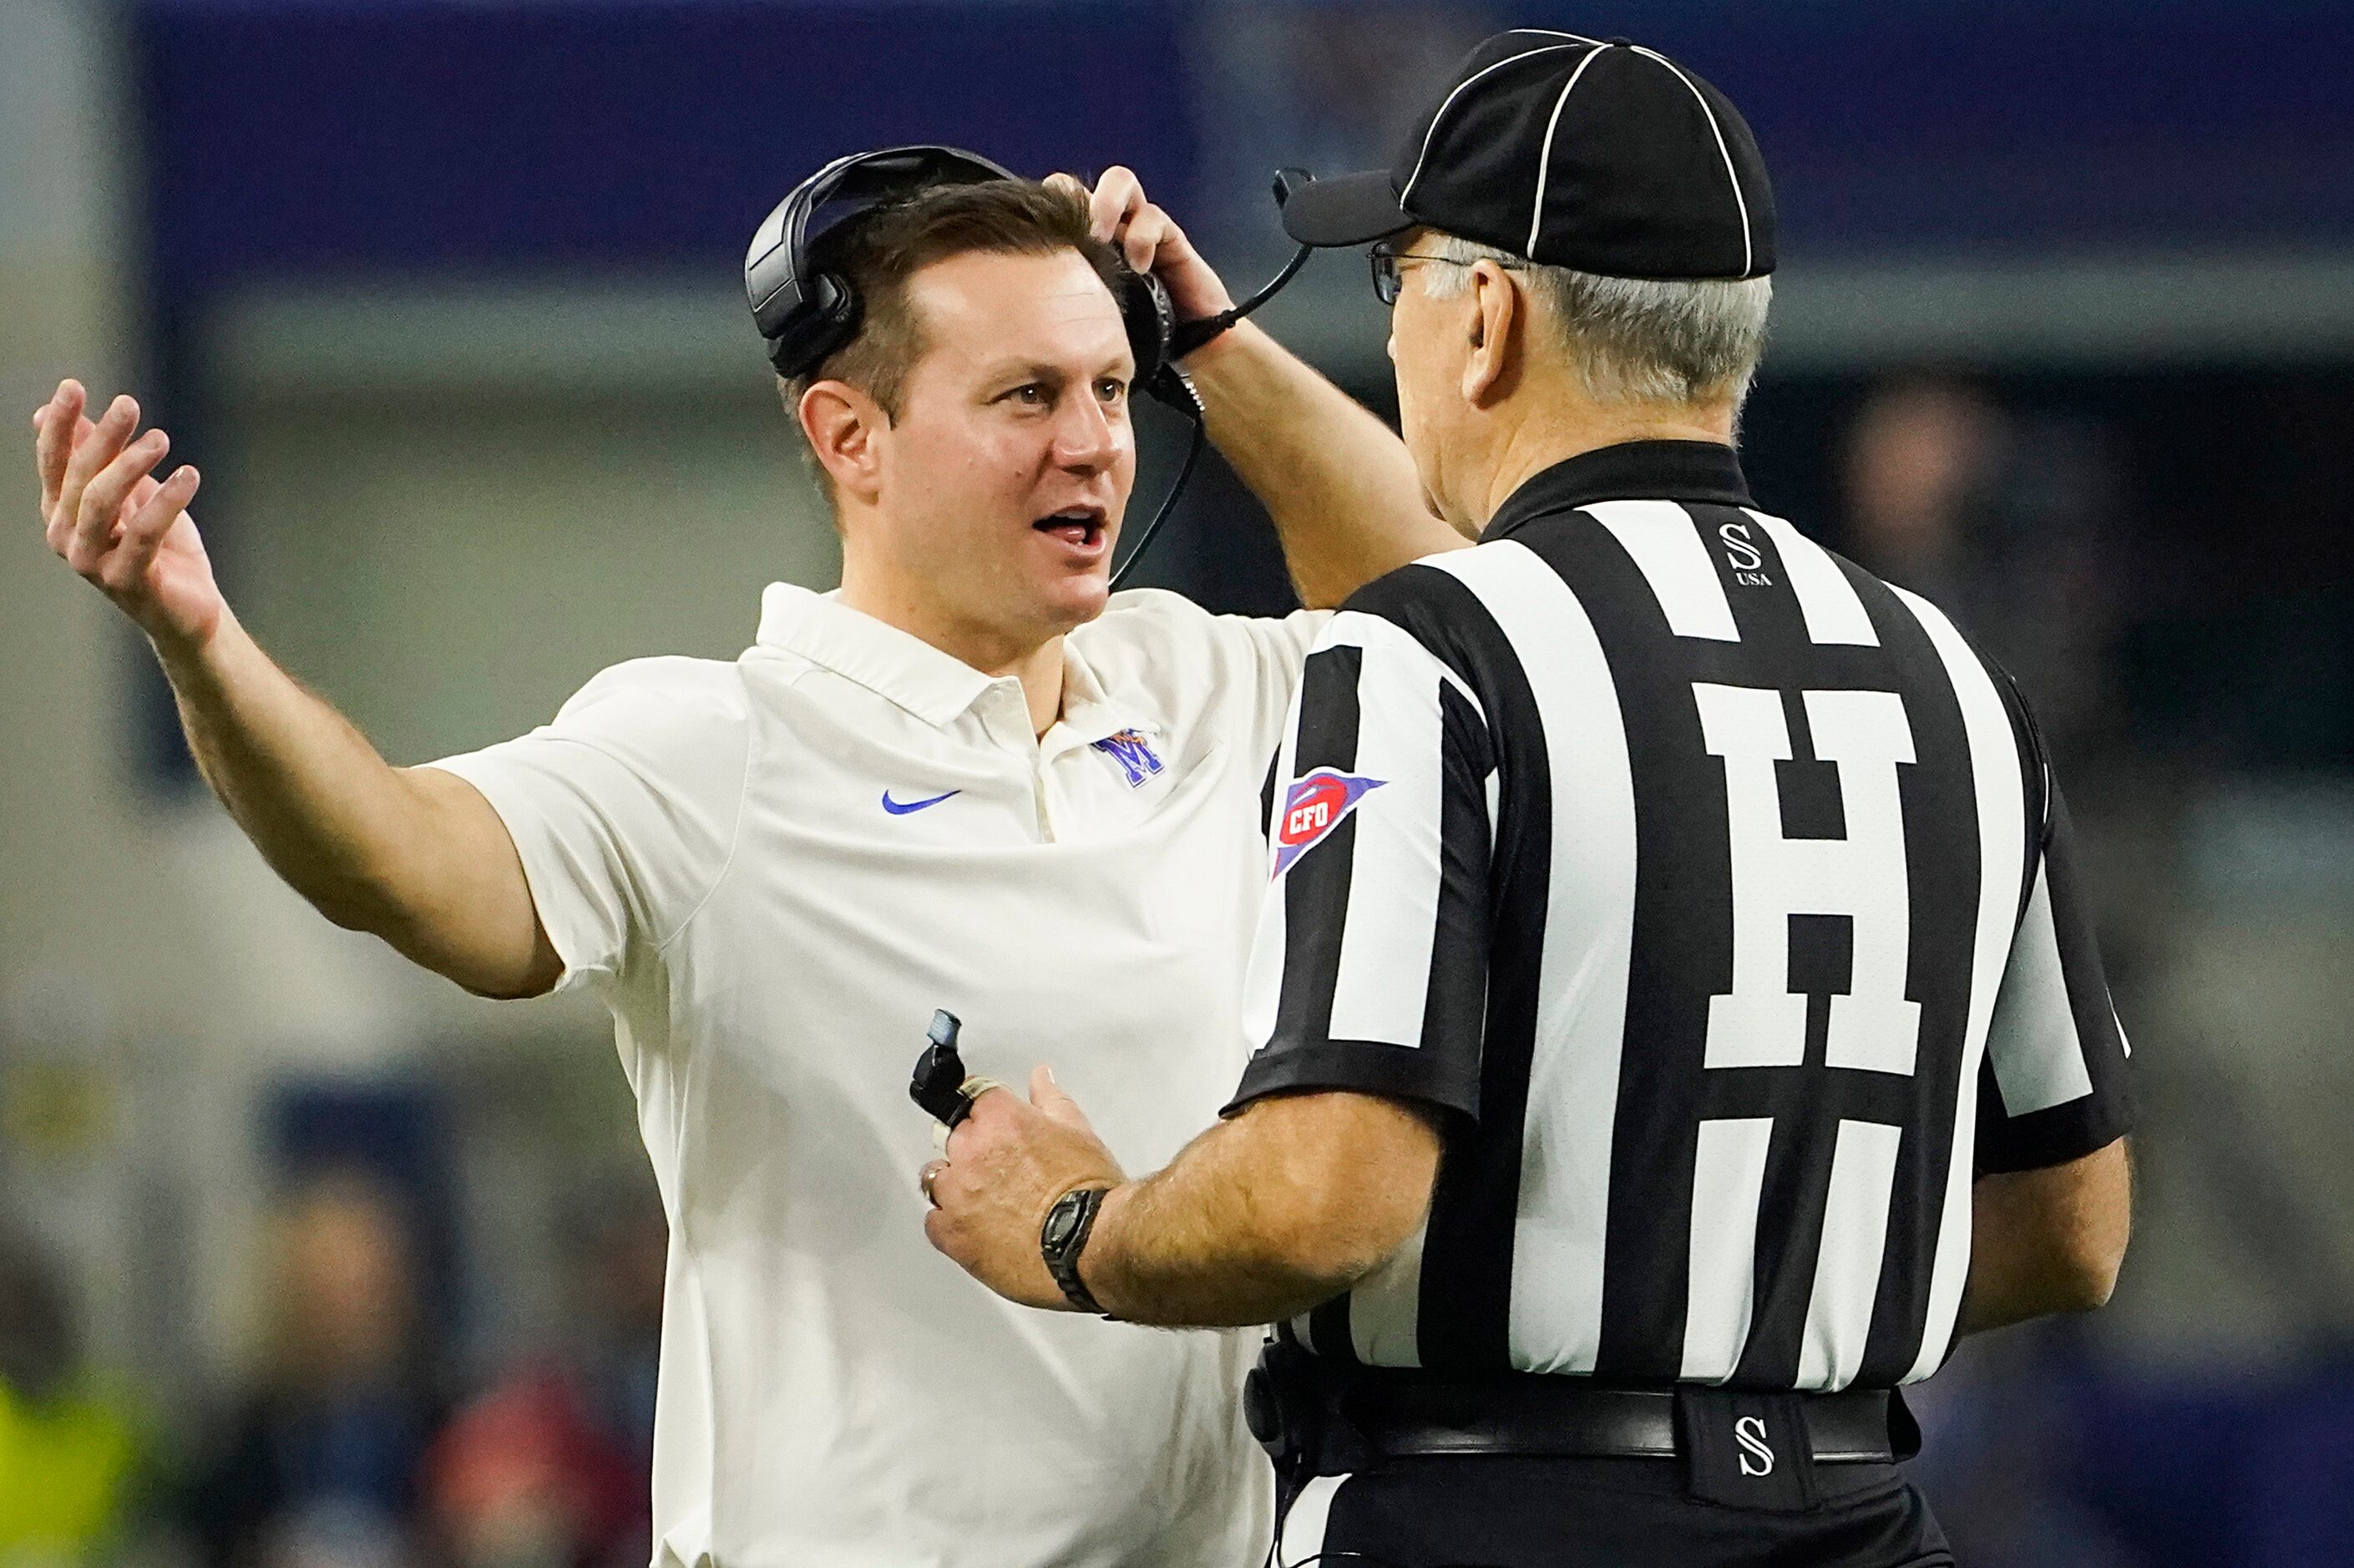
[0,1236,144,1568]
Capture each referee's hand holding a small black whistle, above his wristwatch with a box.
[918,1066,1127,1312]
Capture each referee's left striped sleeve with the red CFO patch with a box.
[1227,609,1495,1116]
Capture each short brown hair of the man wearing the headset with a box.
[777,179,1121,485]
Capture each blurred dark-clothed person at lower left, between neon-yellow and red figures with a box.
[190,1175,436,1568]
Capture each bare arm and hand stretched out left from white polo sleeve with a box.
[33,379,563,996]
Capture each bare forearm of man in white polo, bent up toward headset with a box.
[1187,320,1464,609]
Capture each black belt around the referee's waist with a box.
[1245,1347,1918,1474]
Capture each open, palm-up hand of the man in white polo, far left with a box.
[33,379,224,647]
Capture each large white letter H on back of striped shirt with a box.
[1693,683,1921,1074]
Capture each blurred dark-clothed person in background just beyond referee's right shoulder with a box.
[1843,374,2119,777]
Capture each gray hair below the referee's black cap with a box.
[1422,229,1773,407]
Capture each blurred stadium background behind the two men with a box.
[0,0,2354,1568]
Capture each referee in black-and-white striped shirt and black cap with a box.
[928,31,2128,1568]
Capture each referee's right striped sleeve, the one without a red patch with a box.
[1977,787,2133,1172]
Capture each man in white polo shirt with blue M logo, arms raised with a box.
[35,160,1452,1568]
